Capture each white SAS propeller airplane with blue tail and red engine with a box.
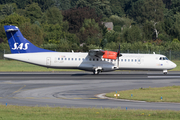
[4,25,176,74]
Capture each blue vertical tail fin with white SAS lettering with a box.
[4,25,54,53]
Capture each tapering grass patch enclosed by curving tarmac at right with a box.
[106,86,180,103]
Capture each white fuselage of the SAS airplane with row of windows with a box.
[4,52,176,71]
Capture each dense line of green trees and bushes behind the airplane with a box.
[0,0,180,52]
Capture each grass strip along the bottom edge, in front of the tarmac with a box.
[0,105,180,120]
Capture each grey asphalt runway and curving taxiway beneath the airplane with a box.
[0,71,180,110]
